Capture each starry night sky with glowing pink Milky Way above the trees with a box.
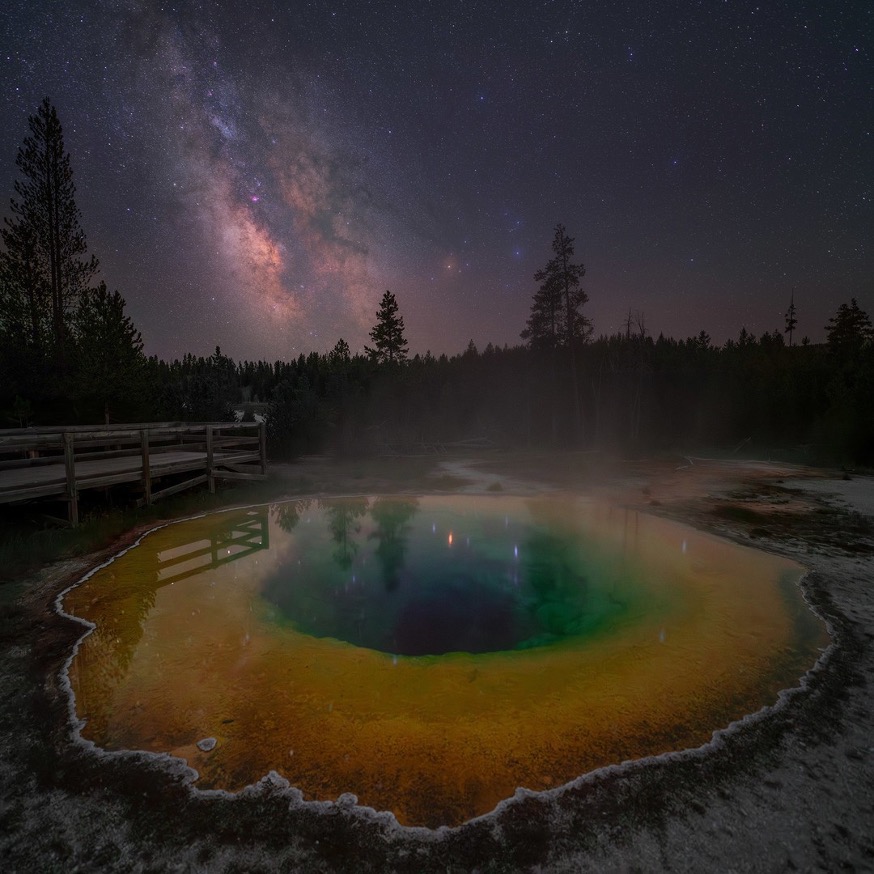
[0,0,874,360]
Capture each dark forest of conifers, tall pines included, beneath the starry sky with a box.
[0,98,874,465]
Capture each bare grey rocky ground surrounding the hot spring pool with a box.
[0,454,874,872]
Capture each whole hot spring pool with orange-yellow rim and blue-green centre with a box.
[63,496,827,827]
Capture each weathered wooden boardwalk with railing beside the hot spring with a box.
[0,422,267,525]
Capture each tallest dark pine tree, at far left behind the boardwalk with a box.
[0,97,98,376]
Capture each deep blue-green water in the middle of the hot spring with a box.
[262,498,652,656]
